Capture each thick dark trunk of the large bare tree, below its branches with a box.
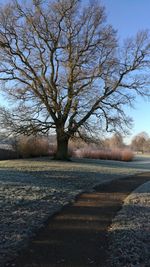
[55,131,69,160]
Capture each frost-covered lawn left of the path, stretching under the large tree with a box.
[0,158,150,266]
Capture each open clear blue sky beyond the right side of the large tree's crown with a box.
[99,0,150,142]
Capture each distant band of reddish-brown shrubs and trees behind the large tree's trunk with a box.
[0,132,150,160]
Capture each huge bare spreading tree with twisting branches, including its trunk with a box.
[0,0,150,159]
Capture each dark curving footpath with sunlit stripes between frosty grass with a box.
[7,173,150,267]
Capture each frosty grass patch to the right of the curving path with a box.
[109,179,150,267]
